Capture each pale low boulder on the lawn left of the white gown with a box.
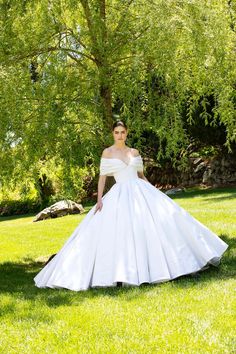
[33,200,85,221]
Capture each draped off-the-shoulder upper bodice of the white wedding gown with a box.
[100,155,143,182]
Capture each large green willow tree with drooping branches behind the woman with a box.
[0,0,236,195]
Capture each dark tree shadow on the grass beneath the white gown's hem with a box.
[0,235,236,312]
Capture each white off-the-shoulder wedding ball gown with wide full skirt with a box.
[34,155,228,291]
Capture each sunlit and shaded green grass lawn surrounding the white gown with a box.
[0,189,236,354]
